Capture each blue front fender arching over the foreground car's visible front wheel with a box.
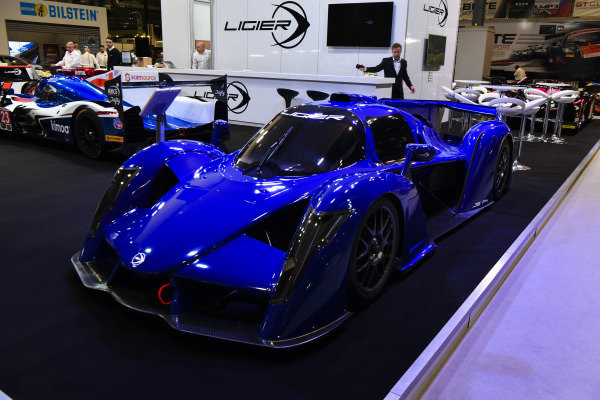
[261,172,427,340]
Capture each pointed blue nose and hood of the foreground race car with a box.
[100,150,342,290]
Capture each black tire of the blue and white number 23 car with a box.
[73,108,104,159]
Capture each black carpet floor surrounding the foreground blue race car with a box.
[0,122,600,400]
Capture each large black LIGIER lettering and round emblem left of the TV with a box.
[225,0,310,49]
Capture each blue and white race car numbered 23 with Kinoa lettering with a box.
[0,75,227,158]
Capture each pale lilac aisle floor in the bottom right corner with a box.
[422,138,600,400]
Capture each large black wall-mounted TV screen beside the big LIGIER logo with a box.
[327,1,394,47]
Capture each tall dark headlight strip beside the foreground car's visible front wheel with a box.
[271,207,350,304]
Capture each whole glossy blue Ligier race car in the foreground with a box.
[72,94,513,347]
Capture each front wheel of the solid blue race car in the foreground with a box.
[346,198,400,309]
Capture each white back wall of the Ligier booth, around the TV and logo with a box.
[162,0,460,99]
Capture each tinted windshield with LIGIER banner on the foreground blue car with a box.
[235,106,366,176]
